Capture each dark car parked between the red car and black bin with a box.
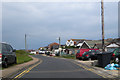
[82,50,100,60]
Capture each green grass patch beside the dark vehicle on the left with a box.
[16,50,32,64]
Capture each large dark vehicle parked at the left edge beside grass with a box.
[0,43,17,67]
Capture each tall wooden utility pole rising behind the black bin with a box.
[101,0,105,52]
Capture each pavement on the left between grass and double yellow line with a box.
[0,56,39,78]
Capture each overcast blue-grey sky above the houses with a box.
[2,2,118,49]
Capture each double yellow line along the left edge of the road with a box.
[12,59,42,80]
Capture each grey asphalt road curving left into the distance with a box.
[11,55,105,78]
